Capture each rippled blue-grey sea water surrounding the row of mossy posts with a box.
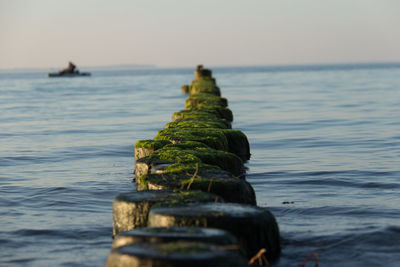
[0,64,400,266]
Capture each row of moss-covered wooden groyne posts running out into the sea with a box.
[106,66,280,266]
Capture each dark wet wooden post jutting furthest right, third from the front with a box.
[148,203,281,261]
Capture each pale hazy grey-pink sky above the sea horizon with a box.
[0,0,400,69]
